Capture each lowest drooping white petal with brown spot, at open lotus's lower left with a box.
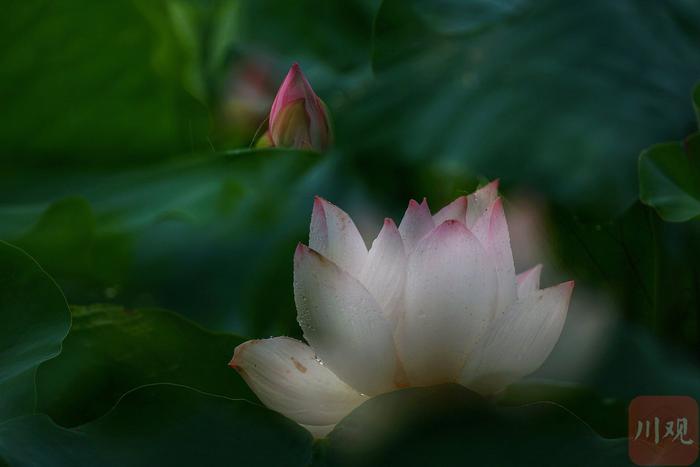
[229,337,366,434]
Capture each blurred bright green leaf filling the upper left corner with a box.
[0,0,208,166]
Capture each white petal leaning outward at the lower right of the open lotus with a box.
[459,281,574,394]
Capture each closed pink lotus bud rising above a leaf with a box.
[258,63,333,151]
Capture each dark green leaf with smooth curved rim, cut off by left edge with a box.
[0,242,70,421]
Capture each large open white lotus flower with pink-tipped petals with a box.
[230,182,574,436]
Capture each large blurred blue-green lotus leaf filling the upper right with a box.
[344,0,700,210]
